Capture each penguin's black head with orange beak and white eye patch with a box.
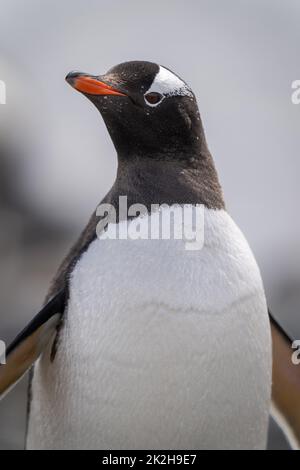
[66,61,205,159]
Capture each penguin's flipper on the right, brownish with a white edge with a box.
[269,312,300,449]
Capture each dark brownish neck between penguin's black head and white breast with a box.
[108,147,225,211]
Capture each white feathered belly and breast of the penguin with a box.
[28,210,271,449]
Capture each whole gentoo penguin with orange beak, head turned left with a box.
[0,61,300,449]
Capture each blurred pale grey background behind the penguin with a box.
[0,0,300,449]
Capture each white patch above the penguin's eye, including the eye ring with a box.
[145,65,193,106]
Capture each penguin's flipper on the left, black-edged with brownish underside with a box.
[0,290,66,400]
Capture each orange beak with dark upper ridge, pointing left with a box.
[66,72,126,96]
